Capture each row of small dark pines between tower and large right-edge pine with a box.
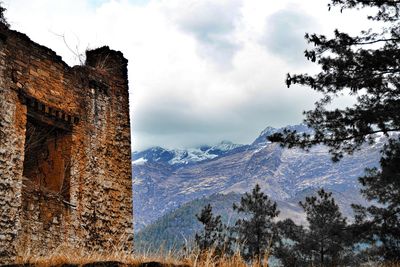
[195,188,361,267]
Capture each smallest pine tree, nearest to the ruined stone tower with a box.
[195,204,226,255]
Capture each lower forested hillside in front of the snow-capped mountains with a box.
[135,188,372,251]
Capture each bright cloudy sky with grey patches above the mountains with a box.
[3,0,369,150]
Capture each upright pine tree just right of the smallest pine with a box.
[233,184,279,262]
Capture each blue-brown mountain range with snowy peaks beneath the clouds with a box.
[133,125,383,230]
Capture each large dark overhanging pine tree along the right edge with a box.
[269,0,400,260]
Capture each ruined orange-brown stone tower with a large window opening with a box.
[0,23,133,263]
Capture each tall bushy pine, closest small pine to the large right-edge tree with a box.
[299,189,352,266]
